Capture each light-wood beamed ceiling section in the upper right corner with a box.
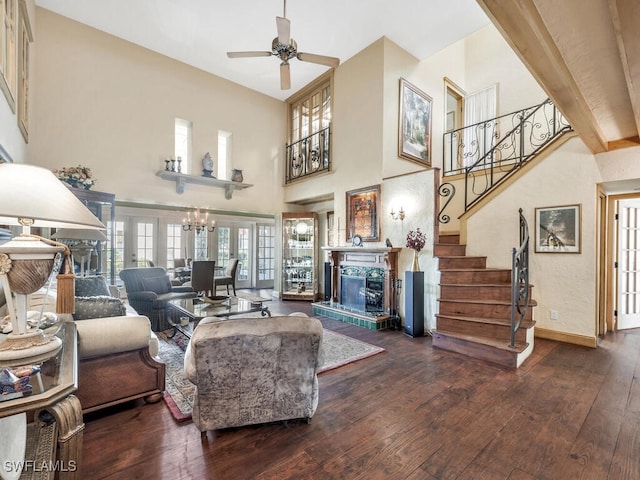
[477,0,640,153]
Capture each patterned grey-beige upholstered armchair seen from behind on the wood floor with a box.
[184,316,322,437]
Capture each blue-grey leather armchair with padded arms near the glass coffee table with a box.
[120,267,196,332]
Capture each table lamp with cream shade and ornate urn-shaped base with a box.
[0,163,105,366]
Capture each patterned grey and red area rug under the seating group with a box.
[157,329,384,422]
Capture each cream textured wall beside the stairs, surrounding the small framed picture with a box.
[467,137,600,339]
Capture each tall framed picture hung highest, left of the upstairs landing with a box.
[398,78,432,167]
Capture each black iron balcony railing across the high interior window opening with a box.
[285,127,331,184]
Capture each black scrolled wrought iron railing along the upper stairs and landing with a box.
[440,99,572,213]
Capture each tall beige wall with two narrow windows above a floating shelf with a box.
[28,9,286,212]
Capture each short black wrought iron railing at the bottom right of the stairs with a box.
[509,209,529,348]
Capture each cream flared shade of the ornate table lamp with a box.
[0,163,105,230]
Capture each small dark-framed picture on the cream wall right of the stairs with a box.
[535,205,581,253]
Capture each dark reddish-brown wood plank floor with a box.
[82,292,640,480]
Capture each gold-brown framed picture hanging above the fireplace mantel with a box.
[346,185,380,242]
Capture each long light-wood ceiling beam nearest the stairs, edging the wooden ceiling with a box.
[477,0,608,154]
